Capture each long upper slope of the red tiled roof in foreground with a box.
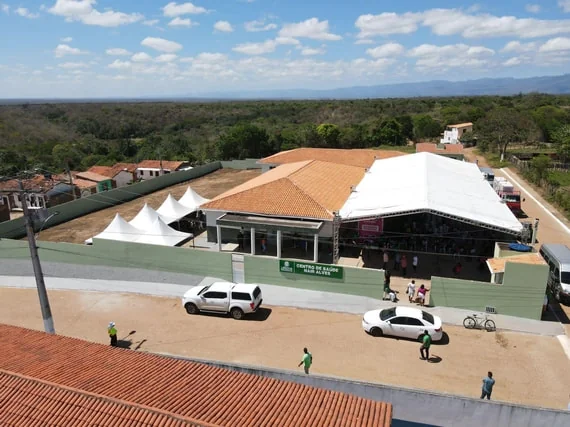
[0,325,392,427]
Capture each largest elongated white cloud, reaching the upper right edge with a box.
[355,8,570,39]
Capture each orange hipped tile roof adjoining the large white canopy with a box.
[201,160,365,219]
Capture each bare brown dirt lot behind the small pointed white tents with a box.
[39,169,261,244]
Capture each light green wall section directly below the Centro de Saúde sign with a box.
[244,255,384,299]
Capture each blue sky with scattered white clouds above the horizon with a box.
[0,0,570,98]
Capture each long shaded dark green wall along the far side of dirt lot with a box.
[0,162,221,239]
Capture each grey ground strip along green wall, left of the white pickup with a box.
[0,259,204,286]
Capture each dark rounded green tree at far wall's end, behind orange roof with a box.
[216,124,272,160]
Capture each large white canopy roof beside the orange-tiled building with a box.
[340,153,523,234]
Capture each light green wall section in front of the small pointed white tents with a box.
[0,239,232,280]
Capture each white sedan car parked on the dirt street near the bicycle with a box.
[362,307,443,341]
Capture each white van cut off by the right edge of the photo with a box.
[540,243,570,303]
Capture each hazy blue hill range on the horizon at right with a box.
[189,74,570,99]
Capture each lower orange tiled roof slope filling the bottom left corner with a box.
[0,370,204,427]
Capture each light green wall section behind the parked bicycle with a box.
[430,262,548,320]
